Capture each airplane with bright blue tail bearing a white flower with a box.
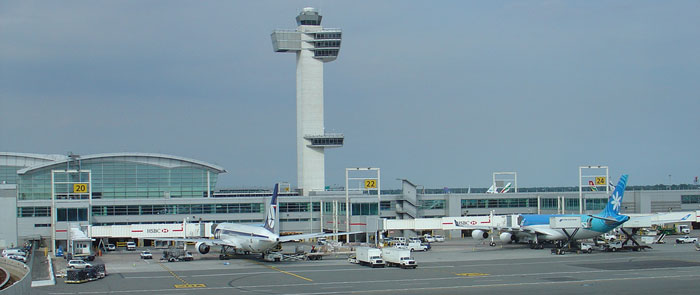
[455,174,630,245]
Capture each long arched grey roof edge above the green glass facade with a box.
[17,153,226,174]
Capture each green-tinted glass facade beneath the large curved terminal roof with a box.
[18,157,218,200]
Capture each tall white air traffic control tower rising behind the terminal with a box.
[271,7,344,196]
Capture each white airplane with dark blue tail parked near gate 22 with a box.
[155,184,361,255]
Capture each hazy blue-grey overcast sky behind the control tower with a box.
[0,0,700,188]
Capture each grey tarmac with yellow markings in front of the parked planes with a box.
[32,236,700,295]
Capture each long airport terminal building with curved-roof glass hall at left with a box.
[0,152,700,251]
